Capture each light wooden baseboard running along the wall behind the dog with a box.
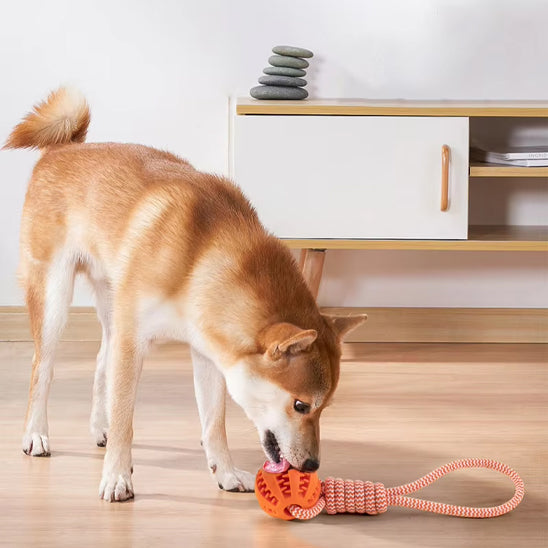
[0,307,548,343]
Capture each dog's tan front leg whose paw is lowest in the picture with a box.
[99,334,143,502]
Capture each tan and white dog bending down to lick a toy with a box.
[4,88,365,502]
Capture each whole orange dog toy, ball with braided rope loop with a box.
[255,459,525,520]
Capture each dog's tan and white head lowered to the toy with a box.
[226,316,366,472]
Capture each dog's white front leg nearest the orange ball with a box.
[191,348,255,492]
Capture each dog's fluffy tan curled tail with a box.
[4,87,90,149]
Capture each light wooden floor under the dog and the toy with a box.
[0,342,548,548]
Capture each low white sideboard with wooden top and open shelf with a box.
[232,99,548,251]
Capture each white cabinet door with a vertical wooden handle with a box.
[234,115,468,239]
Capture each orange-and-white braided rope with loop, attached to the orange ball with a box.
[288,459,525,520]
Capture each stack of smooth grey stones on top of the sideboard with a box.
[249,46,314,99]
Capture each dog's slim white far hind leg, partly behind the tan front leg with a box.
[90,276,112,447]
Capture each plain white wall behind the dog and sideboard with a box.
[0,0,548,307]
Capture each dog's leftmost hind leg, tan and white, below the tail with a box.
[23,256,75,457]
